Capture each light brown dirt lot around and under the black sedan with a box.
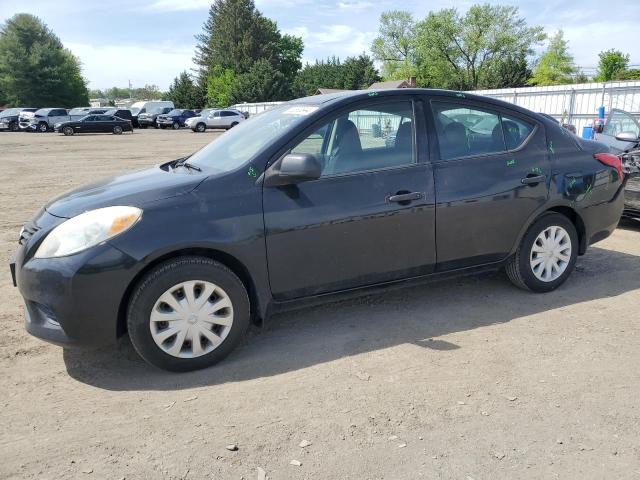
[0,131,640,480]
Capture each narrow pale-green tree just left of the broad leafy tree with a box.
[371,10,415,80]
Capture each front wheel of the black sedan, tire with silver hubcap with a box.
[127,257,250,372]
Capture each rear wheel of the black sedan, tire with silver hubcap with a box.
[506,213,579,293]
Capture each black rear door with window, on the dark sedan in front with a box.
[430,98,551,271]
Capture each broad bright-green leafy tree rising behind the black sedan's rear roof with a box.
[415,4,545,90]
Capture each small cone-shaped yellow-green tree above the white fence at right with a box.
[529,30,578,85]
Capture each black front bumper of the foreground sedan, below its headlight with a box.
[10,212,136,345]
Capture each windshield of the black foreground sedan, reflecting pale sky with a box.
[189,104,318,172]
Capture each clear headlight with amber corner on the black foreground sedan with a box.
[35,207,142,258]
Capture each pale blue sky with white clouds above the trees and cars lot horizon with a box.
[0,0,640,90]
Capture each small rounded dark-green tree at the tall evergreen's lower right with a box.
[230,59,289,103]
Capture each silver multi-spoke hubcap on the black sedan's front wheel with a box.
[149,280,233,358]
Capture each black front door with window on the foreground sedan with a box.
[263,96,435,299]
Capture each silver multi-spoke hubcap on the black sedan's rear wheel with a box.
[529,226,571,282]
